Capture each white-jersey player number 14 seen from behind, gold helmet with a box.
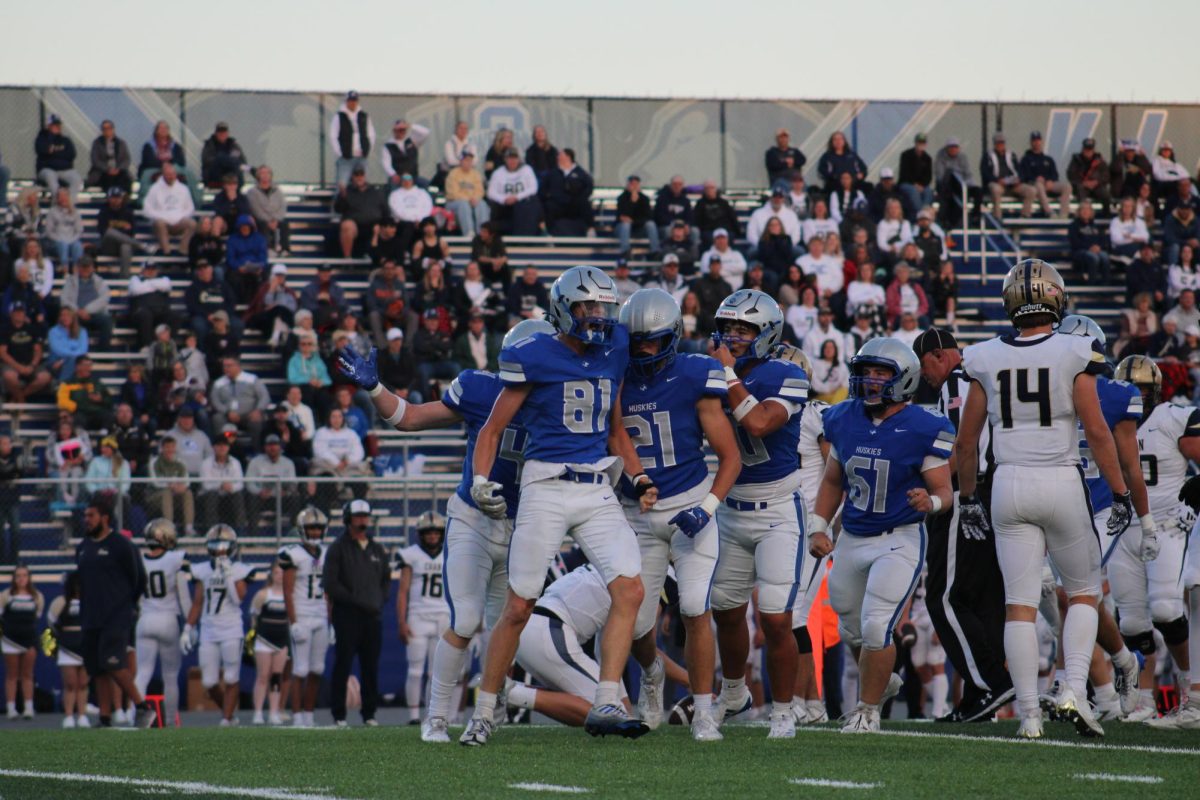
[956,259,1153,738]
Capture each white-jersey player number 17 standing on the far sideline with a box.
[179,523,254,728]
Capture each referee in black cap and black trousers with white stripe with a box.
[912,327,1013,722]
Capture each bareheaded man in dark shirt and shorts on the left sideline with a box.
[76,500,157,728]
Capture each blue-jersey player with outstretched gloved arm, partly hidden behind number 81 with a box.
[337,319,554,744]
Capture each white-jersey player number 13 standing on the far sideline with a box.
[277,506,329,728]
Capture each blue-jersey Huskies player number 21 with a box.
[619,289,742,741]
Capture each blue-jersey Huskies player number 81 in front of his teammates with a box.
[458,266,658,746]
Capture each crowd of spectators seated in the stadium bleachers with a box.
[0,92,1200,560]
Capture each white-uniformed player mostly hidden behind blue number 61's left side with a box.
[775,344,829,724]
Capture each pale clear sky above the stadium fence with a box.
[0,0,1200,103]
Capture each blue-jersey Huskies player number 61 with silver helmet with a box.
[809,338,954,733]
